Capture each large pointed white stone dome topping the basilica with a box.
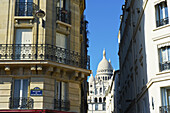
[97,50,113,75]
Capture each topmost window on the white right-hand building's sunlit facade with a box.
[155,1,169,27]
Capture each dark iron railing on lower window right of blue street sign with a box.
[54,99,70,111]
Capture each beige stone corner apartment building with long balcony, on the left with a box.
[0,0,91,113]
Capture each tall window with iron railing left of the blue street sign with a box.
[10,79,29,109]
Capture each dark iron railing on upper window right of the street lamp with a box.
[56,7,71,24]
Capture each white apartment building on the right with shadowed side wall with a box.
[116,0,170,113]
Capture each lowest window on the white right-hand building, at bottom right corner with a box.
[160,87,170,113]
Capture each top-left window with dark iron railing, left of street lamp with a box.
[15,0,33,16]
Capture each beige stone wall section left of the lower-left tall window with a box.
[0,78,12,109]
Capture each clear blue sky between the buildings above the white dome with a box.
[85,0,124,76]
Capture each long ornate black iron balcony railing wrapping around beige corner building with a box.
[0,44,90,69]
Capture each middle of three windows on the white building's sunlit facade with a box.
[159,46,170,71]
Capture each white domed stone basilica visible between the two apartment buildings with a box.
[88,50,114,113]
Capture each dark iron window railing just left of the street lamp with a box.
[15,2,38,16]
